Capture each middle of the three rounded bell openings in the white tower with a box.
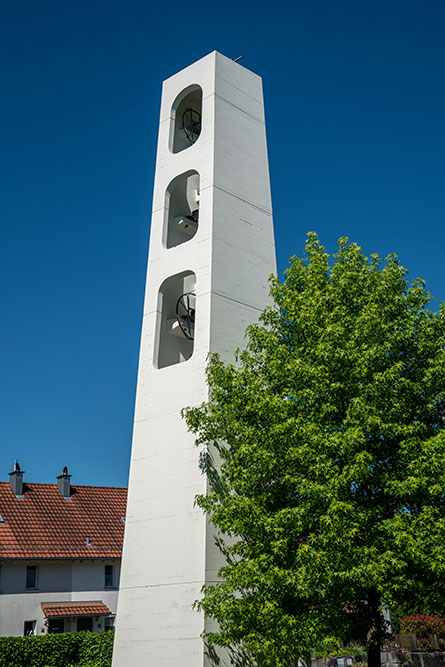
[164,171,199,248]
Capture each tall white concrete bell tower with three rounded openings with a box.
[113,52,276,667]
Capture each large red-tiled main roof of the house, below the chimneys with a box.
[0,482,127,560]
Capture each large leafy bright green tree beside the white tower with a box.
[184,234,445,667]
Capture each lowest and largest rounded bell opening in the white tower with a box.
[154,271,196,368]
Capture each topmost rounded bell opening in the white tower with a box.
[170,85,202,153]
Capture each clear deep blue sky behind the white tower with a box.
[0,0,445,486]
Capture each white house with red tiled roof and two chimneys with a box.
[0,461,127,636]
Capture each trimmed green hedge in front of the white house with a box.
[0,632,114,667]
